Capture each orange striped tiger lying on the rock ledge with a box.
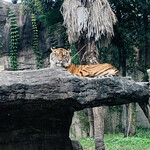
[50,48,119,78]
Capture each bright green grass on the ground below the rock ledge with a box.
[73,128,150,150]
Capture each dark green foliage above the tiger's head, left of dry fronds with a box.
[22,0,65,47]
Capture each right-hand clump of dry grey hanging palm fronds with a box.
[87,0,116,45]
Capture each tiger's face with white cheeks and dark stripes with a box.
[50,48,71,67]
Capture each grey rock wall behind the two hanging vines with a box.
[0,1,50,70]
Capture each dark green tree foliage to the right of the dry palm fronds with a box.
[104,0,150,74]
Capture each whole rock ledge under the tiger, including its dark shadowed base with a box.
[0,68,149,150]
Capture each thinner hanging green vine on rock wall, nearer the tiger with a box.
[32,14,42,69]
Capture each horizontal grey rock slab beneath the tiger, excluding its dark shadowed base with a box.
[0,68,149,110]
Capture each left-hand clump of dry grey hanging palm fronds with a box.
[61,0,89,43]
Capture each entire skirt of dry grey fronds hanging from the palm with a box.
[61,0,116,44]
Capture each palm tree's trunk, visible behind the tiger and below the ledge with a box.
[85,40,105,150]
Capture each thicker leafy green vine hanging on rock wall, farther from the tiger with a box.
[8,8,19,71]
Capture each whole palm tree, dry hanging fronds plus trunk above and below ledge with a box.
[61,0,117,149]
